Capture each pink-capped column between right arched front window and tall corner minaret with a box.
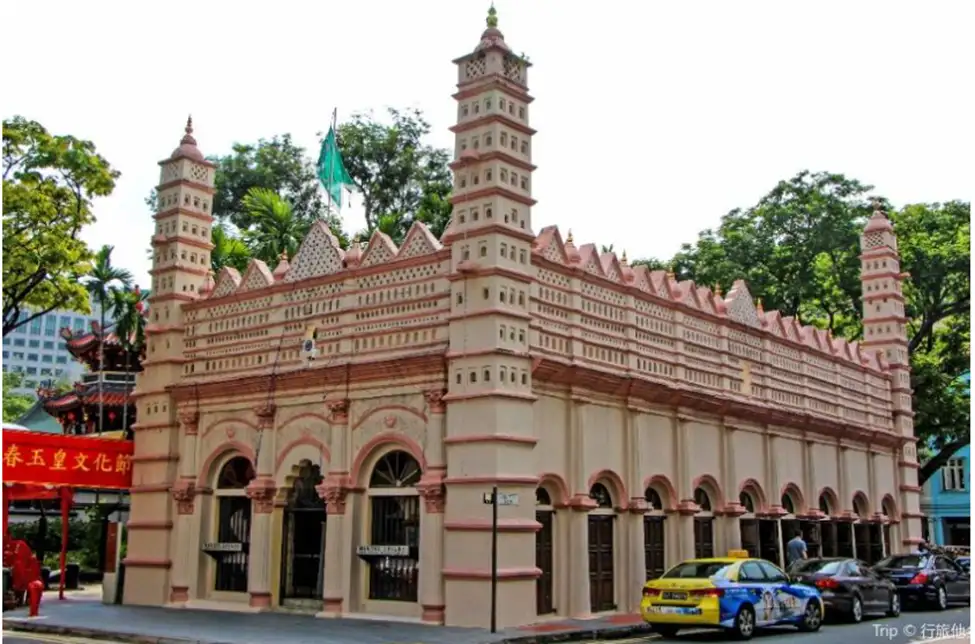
[417,389,447,624]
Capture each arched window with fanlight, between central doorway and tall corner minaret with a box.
[367,450,422,602]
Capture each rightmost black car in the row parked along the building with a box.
[873,553,971,610]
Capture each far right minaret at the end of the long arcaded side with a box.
[860,204,921,552]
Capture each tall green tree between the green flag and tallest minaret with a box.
[338,108,452,243]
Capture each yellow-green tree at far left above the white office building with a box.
[3,116,119,336]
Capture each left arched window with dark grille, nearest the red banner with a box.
[212,456,254,593]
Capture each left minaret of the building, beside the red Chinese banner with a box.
[125,119,215,606]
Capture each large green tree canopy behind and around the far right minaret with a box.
[634,171,971,472]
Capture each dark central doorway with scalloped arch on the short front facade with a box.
[281,460,327,604]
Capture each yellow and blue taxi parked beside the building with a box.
[640,550,823,640]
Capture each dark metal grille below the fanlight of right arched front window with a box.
[368,495,420,602]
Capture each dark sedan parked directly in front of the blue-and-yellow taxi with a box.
[789,558,901,622]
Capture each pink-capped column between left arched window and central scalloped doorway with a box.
[247,403,277,610]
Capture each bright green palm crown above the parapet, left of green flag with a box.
[242,188,308,262]
